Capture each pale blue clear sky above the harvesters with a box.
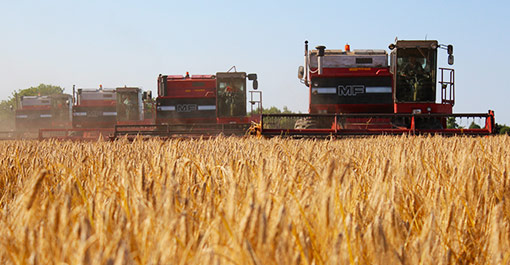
[0,0,510,124]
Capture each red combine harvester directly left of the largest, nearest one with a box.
[113,69,262,138]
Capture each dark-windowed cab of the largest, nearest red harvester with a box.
[389,40,455,114]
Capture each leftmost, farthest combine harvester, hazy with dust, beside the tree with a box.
[15,94,72,138]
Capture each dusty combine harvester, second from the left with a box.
[39,86,153,140]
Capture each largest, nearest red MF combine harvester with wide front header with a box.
[260,40,495,137]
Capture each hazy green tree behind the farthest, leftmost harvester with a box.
[0,84,64,130]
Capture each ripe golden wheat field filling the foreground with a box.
[0,136,510,264]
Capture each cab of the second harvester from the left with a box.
[115,86,144,123]
